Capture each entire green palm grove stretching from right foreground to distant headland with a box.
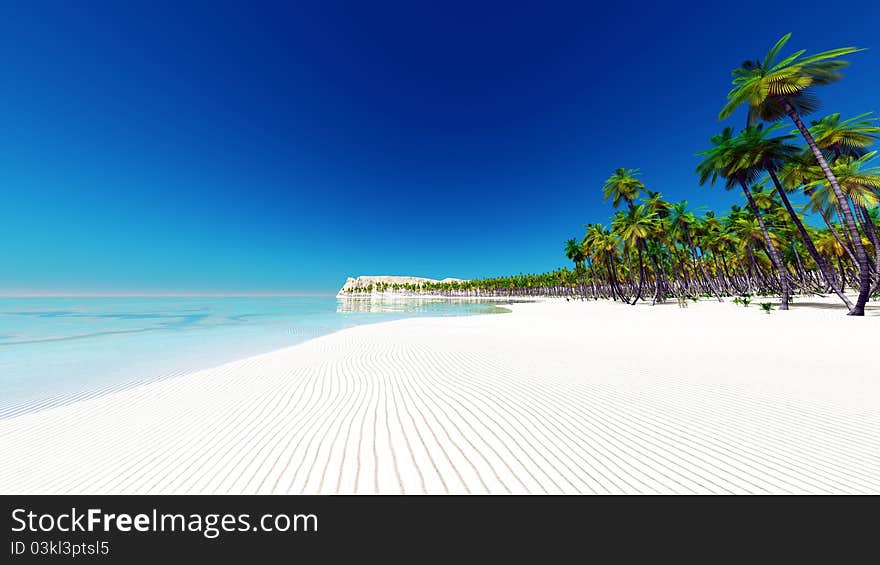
[352,34,880,316]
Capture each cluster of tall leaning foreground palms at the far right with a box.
[712,34,878,316]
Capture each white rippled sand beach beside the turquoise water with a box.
[0,298,880,494]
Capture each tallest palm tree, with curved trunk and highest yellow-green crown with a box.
[718,33,871,316]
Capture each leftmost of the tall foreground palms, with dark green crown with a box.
[697,127,791,310]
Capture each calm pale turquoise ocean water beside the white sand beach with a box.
[0,296,505,418]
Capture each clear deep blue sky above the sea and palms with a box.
[0,0,880,292]
